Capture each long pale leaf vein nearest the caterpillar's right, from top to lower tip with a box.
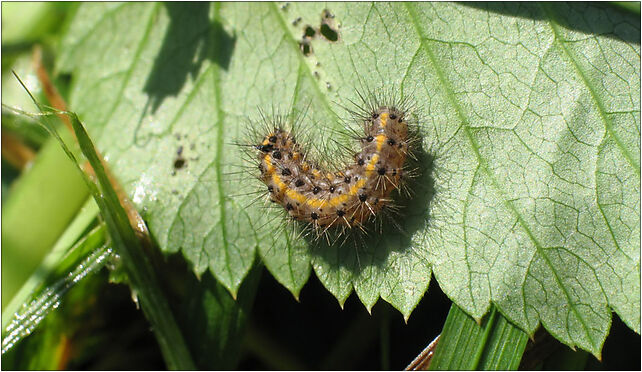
[404,3,594,345]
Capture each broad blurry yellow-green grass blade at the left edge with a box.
[2,126,89,309]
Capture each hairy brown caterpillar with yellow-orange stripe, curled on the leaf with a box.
[248,94,418,236]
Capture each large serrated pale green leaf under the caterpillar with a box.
[53,3,640,355]
